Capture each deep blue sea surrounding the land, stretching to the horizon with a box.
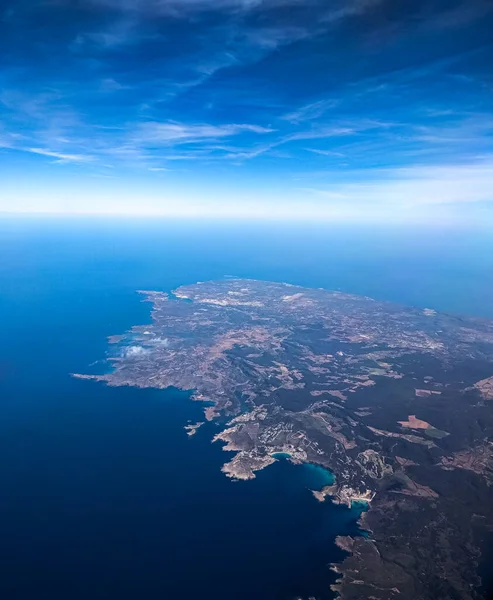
[0,218,493,600]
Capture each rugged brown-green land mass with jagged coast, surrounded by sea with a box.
[77,279,493,600]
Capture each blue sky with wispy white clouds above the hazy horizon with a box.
[0,0,493,225]
